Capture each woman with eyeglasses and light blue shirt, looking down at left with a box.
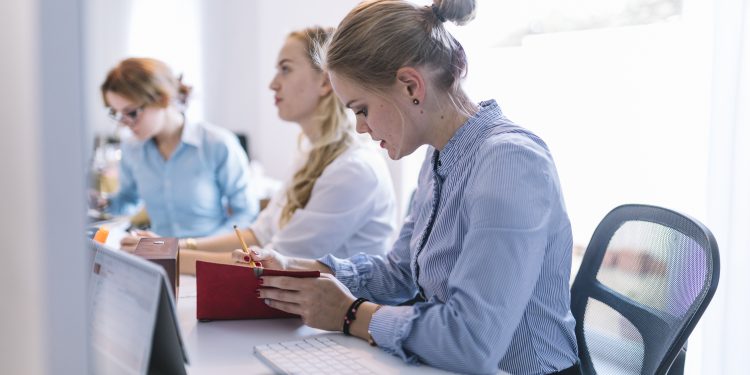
[101,58,258,241]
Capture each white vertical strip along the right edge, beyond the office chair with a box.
[704,0,750,374]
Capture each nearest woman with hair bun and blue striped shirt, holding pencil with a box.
[234,0,581,374]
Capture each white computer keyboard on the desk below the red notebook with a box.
[255,337,374,375]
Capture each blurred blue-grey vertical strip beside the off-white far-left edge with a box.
[34,0,90,374]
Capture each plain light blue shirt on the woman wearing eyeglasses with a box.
[109,122,259,237]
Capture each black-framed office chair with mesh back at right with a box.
[571,205,719,374]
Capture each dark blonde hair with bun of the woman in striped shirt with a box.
[324,0,476,110]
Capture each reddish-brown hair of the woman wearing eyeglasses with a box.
[101,57,192,108]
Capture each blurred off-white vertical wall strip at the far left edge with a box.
[0,0,45,374]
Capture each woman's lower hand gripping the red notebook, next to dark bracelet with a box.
[259,274,355,331]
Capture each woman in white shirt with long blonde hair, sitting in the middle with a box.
[168,27,396,274]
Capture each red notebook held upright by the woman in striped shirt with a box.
[195,261,320,320]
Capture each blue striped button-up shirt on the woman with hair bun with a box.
[321,101,577,374]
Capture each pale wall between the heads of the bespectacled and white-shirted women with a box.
[203,0,357,179]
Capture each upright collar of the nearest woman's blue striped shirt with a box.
[433,100,502,177]
